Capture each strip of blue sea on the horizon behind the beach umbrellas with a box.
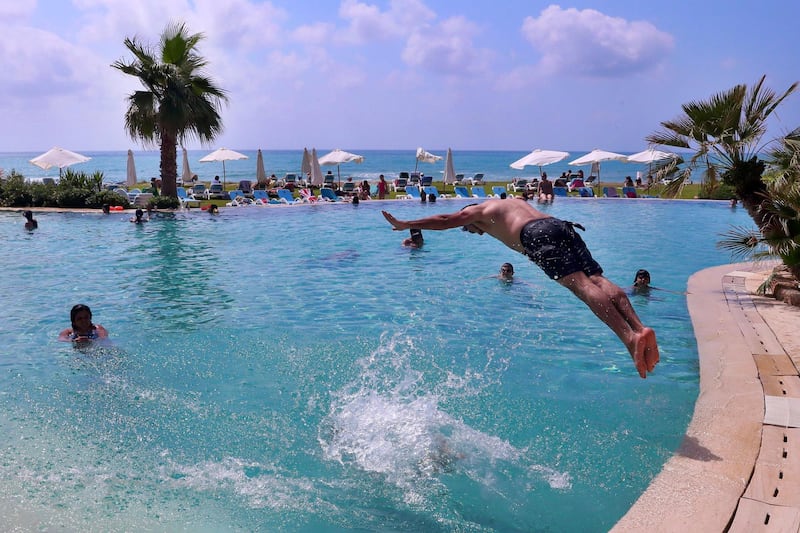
[0,148,664,184]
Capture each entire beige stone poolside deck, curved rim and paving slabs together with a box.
[613,264,800,533]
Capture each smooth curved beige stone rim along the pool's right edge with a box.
[612,263,800,532]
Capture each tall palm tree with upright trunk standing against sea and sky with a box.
[111,24,228,198]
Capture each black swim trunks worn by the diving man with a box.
[519,217,603,280]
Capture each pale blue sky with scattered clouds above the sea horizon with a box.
[0,0,800,152]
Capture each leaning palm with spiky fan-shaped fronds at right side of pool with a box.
[646,76,798,224]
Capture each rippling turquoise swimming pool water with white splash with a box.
[0,199,748,531]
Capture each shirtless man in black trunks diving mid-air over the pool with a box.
[383,199,659,378]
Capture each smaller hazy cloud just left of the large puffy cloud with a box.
[402,16,491,76]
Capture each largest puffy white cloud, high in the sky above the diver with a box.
[522,5,674,78]
